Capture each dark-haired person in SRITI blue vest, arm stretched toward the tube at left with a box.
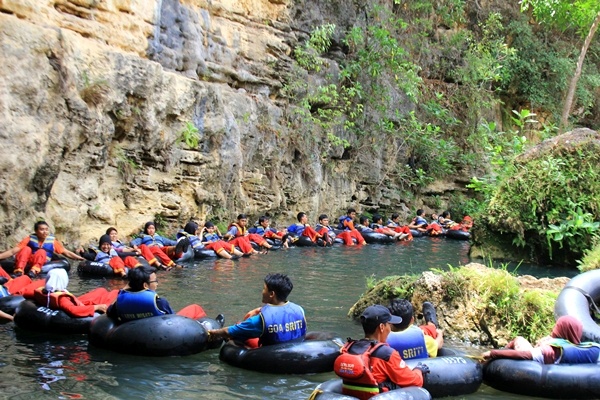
[208,274,306,346]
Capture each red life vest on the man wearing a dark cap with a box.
[333,340,386,400]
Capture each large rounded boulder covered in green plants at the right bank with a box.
[472,132,600,264]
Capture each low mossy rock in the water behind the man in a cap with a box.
[348,263,569,347]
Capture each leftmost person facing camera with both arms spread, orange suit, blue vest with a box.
[0,221,85,277]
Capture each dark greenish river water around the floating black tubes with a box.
[0,238,576,400]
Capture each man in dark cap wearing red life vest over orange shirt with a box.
[334,305,429,399]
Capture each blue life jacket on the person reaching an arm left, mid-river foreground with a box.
[259,301,306,346]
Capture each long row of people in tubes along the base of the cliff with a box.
[0,208,472,278]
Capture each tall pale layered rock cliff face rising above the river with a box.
[0,0,466,248]
